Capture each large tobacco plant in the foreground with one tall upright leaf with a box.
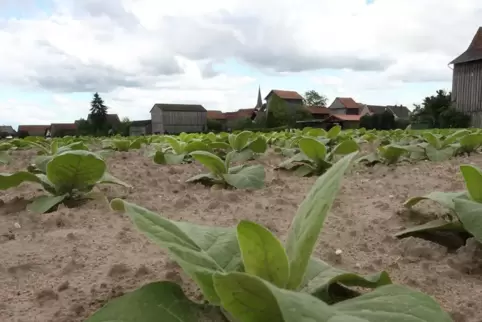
[87,154,451,322]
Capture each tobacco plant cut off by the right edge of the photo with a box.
[395,165,482,243]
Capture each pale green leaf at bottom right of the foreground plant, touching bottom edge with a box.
[330,285,452,322]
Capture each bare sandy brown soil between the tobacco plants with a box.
[0,151,482,322]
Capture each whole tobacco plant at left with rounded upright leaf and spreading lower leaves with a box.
[0,150,129,213]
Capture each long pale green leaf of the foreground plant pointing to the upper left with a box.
[111,199,242,303]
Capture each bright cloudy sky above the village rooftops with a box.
[0,0,482,126]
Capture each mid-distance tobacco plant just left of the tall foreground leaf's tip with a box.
[186,151,265,189]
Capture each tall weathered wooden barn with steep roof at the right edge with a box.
[450,27,482,127]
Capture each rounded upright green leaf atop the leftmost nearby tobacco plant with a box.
[47,150,106,192]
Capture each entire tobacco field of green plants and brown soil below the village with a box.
[0,127,482,322]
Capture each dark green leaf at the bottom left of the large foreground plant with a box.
[85,281,202,322]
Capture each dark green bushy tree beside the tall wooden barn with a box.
[410,89,470,128]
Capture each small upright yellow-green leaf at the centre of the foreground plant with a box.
[237,220,290,288]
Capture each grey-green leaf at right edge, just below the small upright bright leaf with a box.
[454,198,482,243]
